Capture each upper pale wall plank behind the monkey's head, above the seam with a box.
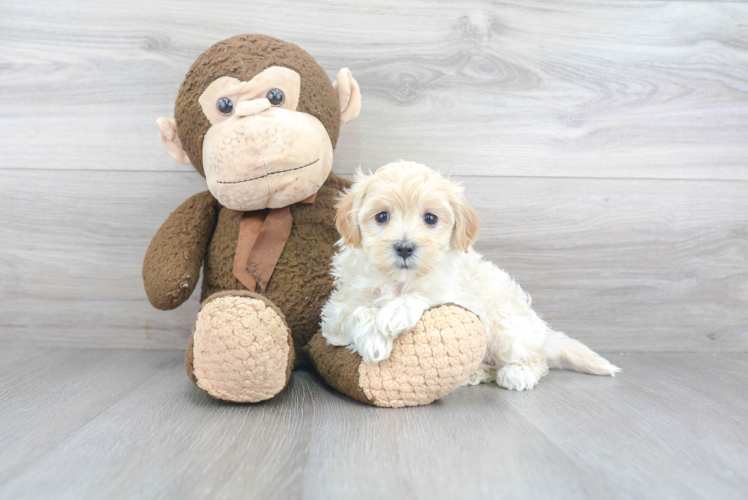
[0,0,748,180]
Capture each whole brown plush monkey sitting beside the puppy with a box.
[143,35,485,406]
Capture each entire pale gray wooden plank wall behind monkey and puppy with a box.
[0,0,748,351]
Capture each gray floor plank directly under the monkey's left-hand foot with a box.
[0,351,312,499]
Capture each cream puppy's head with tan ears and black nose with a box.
[335,161,479,282]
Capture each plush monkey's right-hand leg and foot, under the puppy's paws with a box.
[310,305,486,408]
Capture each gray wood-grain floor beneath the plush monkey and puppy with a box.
[0,347,748,500]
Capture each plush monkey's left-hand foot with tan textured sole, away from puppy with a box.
[184,290,294,403]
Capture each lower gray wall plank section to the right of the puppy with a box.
[464,178,748,351]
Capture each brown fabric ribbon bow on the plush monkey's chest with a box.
[233,193,317,292]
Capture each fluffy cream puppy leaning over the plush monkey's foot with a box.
[322,161,619,391]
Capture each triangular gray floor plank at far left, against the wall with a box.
[0,346,181,484]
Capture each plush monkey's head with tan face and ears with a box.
[157,35,361,210]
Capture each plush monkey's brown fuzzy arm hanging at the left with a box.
[143,191,218,310]
